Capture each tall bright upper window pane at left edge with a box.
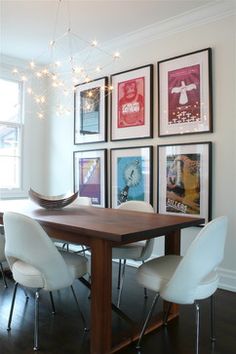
[0,79,20,122]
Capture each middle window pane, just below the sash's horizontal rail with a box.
[0,124,20,156]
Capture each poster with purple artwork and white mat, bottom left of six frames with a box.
[74,149,107,208]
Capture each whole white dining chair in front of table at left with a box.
[3,212,87,350]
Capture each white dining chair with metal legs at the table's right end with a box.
[136,216,227,354]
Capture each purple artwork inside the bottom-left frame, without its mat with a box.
[79,158,101,204]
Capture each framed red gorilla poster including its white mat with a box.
[111,64,153,140]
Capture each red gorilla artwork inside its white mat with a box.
[117,77,145,128]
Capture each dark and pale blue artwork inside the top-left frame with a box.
[80,87,100,135]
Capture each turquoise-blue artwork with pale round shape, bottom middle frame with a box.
[117,156,145,205]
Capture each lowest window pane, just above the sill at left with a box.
[0,156,20,189]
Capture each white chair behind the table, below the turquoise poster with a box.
[112,200,155,307]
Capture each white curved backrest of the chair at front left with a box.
[3,212,74,290]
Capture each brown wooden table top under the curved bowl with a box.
[0,200,204,243]
